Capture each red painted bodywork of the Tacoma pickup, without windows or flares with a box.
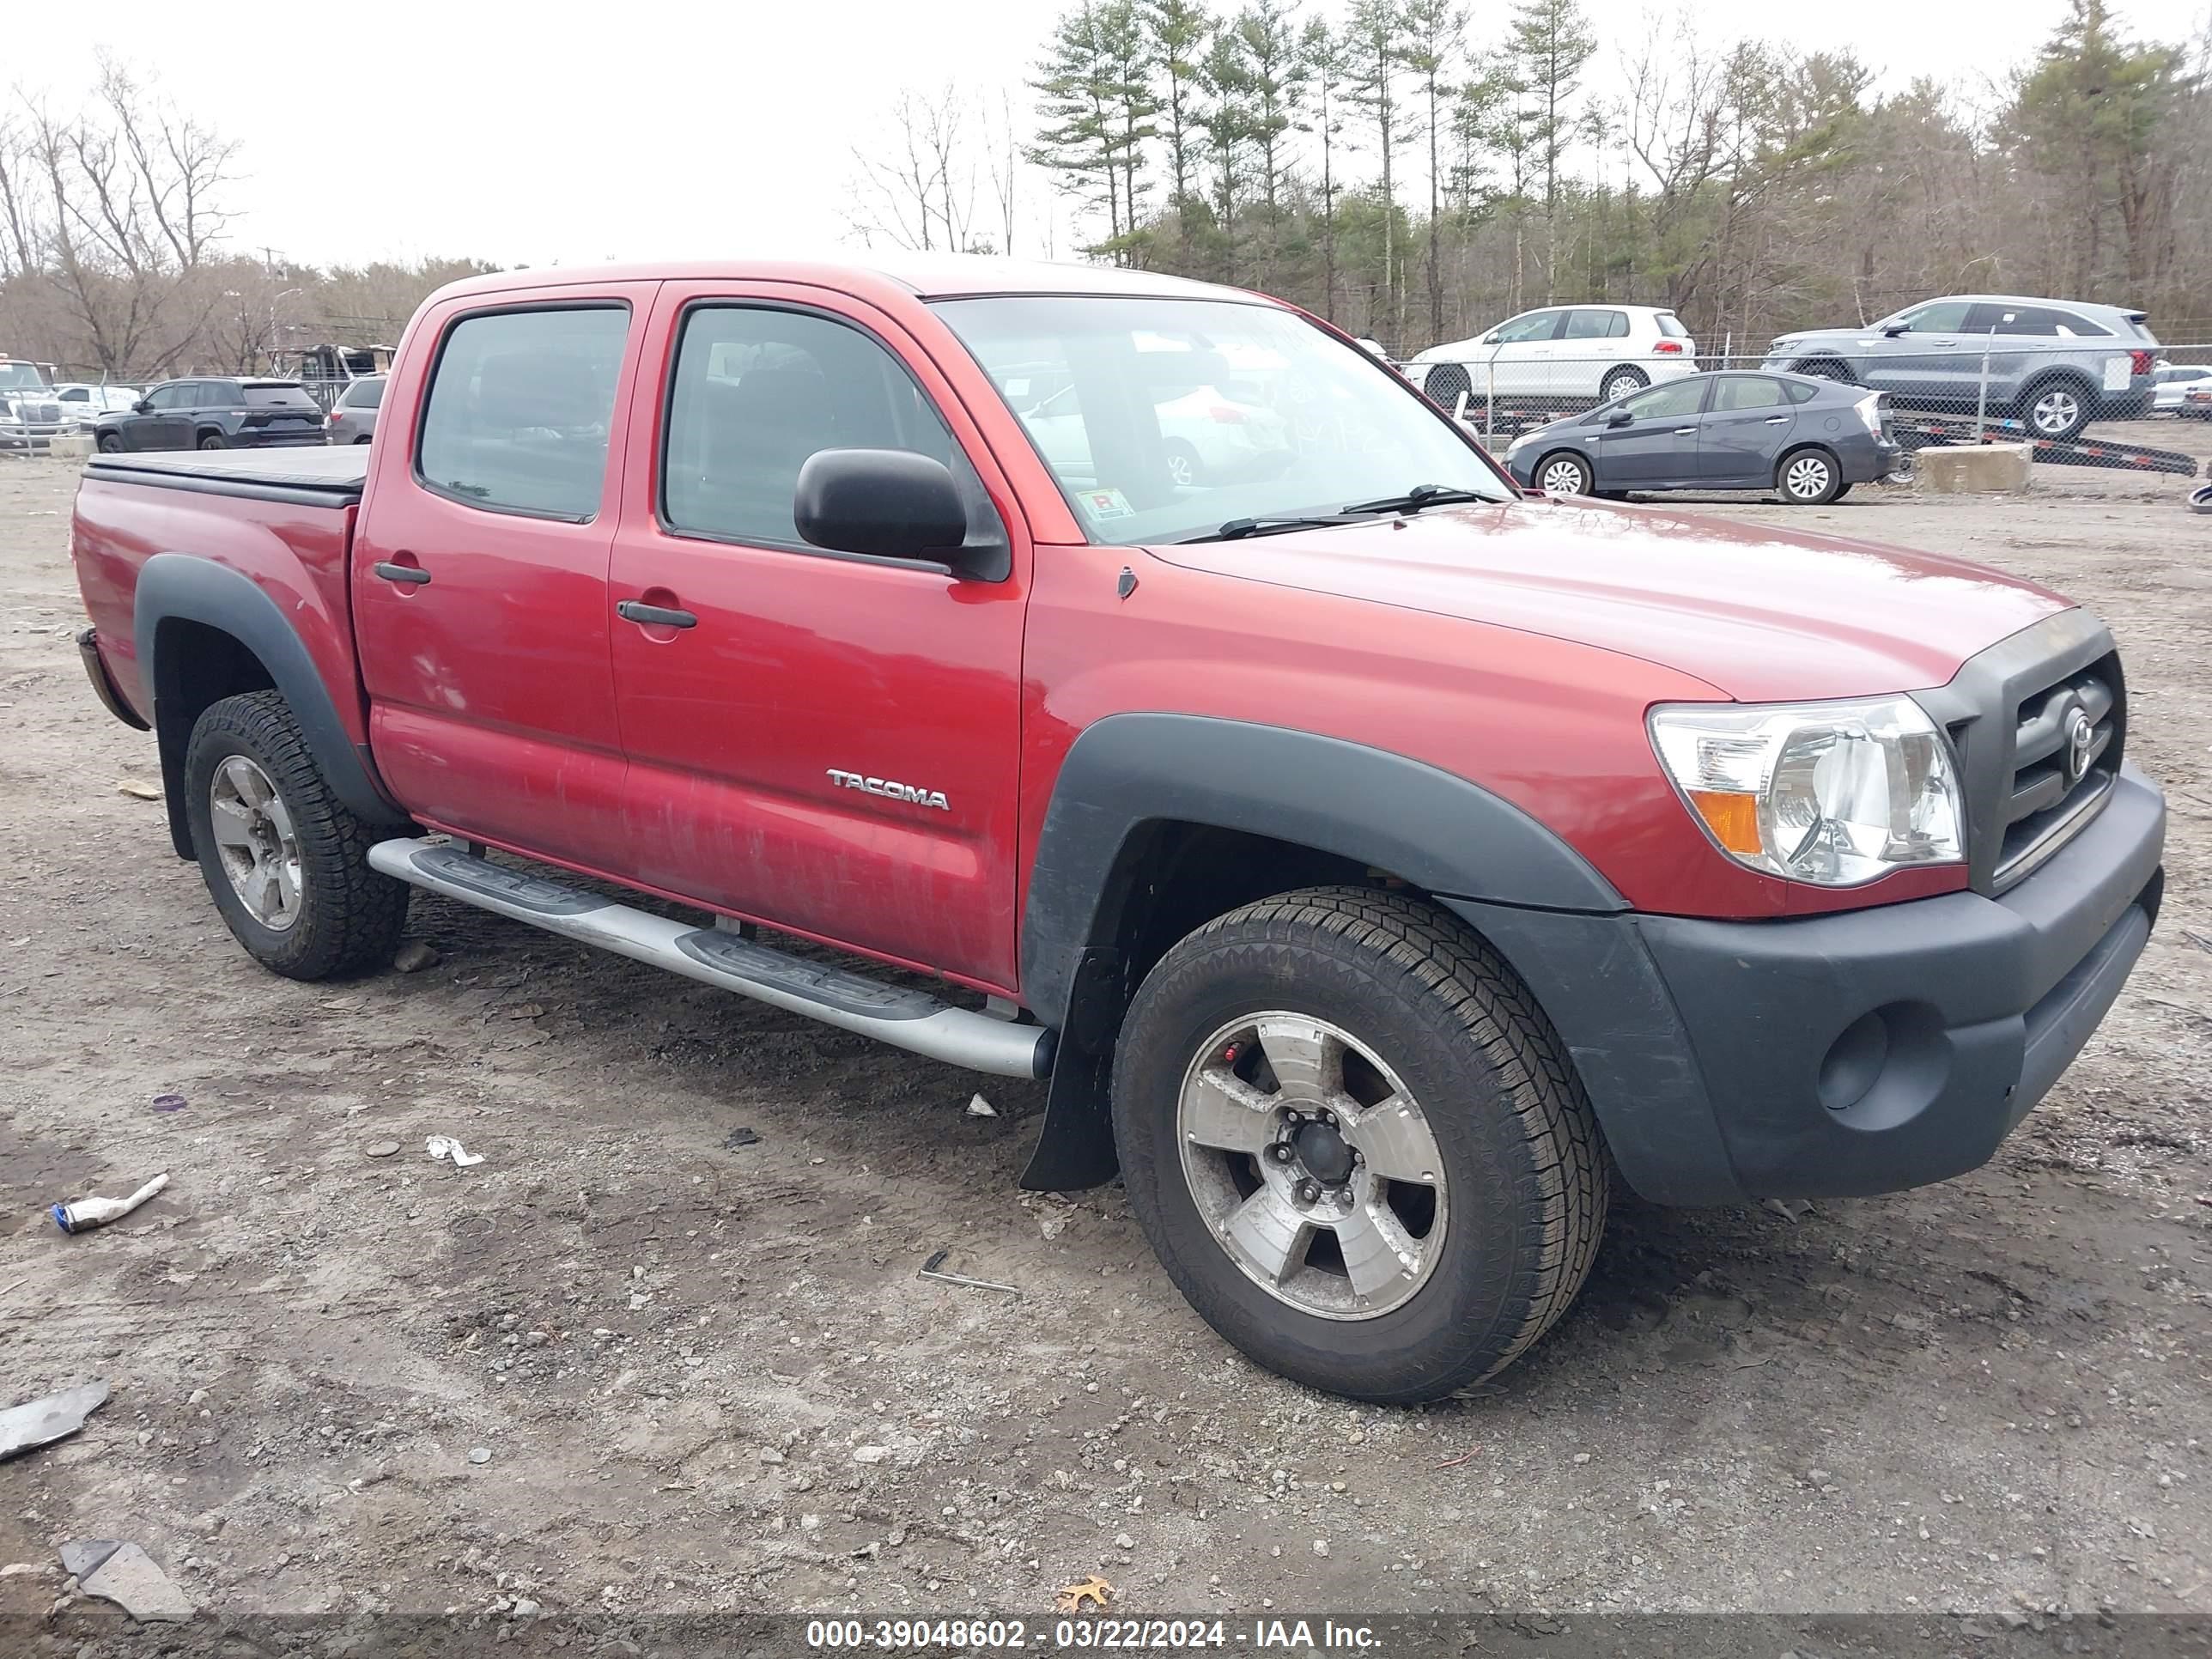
[77,252,2097,998]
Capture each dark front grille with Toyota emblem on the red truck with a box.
[1996,654,2126,887]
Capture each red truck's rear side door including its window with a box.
[352,283,654,874]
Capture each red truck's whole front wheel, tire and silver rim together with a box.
[1113,887,1606,1402]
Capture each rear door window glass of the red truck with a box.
[416,305,630,522]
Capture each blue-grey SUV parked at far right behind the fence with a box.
[1765,295,2159,442]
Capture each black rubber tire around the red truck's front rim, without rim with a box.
[1113,887,1608,1405]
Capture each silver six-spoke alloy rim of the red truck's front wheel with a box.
[1175,1011,1449,1321]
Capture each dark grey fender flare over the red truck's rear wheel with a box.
[131,553,410,858]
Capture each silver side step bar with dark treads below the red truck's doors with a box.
[369,836,1053,1078]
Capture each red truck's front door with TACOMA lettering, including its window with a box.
[608,283,1029,988]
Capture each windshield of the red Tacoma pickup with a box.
[936,295,1516,546]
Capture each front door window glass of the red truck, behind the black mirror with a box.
[661,305,969,549]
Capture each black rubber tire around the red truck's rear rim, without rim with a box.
[184,690,411,980]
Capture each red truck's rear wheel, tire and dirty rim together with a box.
[184,690,411,980]
